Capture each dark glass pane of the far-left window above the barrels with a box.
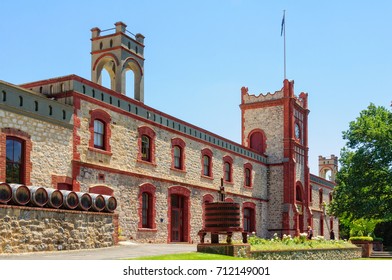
[6,137,24,184]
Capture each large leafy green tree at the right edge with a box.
[329,104,392,221]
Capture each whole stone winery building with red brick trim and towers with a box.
[0,22,338,243]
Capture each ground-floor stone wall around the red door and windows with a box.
[77,167,268,243]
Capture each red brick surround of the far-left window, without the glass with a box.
[0,127,33,185]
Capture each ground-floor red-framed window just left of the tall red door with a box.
[138,183,157,231]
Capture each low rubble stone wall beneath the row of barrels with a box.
[0,205,117,253]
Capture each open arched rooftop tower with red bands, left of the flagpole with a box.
[91,22,144,102]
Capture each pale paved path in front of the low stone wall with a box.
[0,242,196,260]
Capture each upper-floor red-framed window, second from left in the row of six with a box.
[137,126,155,165]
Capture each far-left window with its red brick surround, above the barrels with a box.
[0,128,32,185]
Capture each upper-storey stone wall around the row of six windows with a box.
[78,101,267,198]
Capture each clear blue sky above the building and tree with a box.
[0,0,392,174]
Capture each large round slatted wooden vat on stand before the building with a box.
[204,202,242,232]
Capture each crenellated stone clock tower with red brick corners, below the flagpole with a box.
[240,80,312,235]
